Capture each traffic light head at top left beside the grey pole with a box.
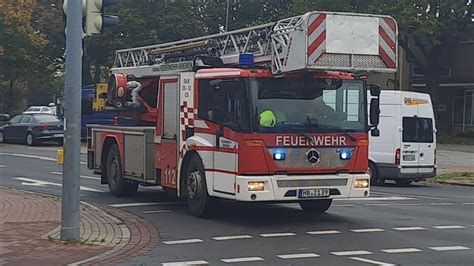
[84,0,120,35]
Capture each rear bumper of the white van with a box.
[376,163,437,181]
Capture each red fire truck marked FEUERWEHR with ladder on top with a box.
[88,12,398,217]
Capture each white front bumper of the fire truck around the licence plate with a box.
[235,174,369,201]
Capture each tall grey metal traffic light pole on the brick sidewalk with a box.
[60,0,82,241]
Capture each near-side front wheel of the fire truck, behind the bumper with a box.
[185,155,213,217]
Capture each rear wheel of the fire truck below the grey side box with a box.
[106,144,138,197]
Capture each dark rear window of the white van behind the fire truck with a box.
[403,117,433,143]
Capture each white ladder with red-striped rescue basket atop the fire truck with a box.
[112,12,398,76]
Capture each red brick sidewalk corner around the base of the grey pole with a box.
[0,187,158,265]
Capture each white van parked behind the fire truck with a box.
[368,90,436,185]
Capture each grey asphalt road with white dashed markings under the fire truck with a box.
[0,145,474,265]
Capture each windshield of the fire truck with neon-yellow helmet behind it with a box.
[249,78,367,133]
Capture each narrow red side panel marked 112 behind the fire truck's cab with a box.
[155,76,179,188]
